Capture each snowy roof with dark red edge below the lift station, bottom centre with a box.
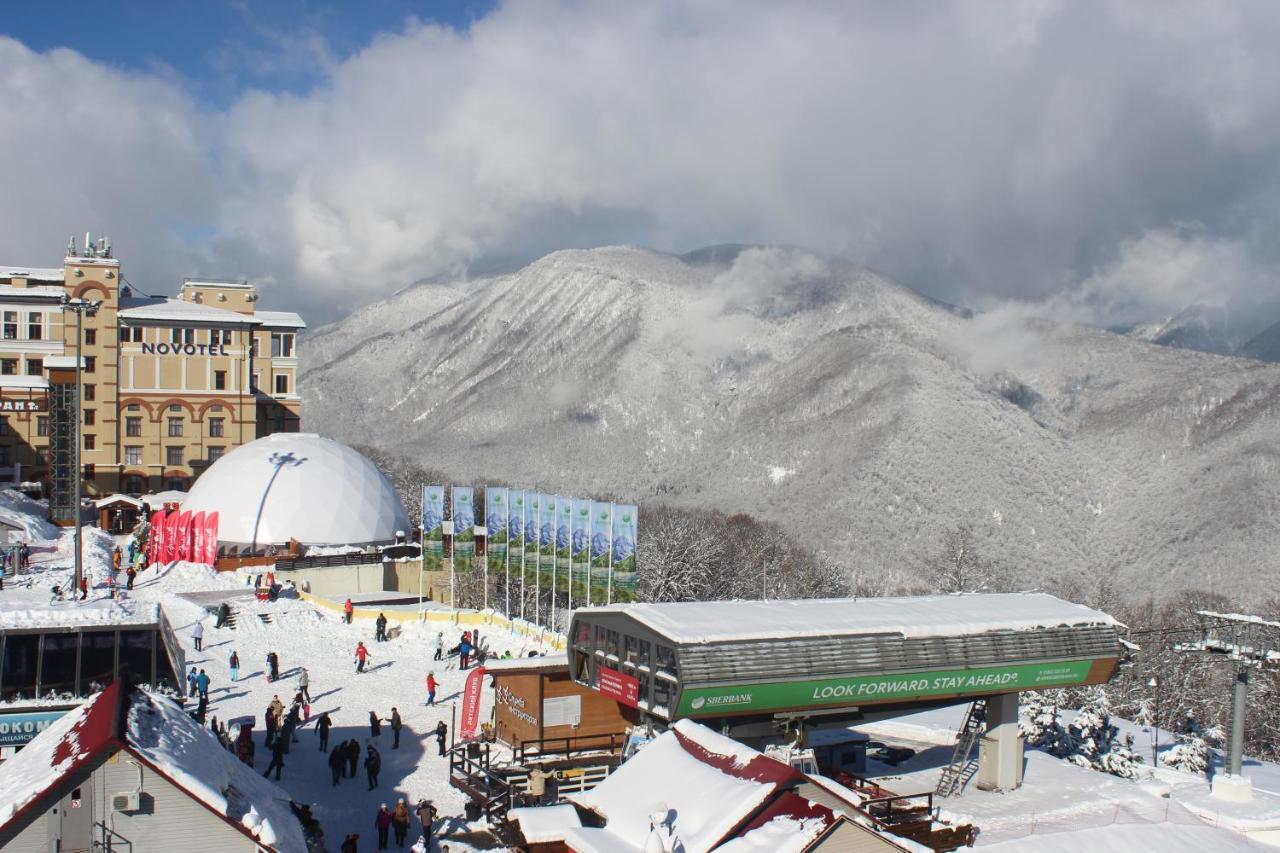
[564,720,804,850]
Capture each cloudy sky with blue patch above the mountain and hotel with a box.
[0,0,1280,327]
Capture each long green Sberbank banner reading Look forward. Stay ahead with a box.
[678,661,1093,716]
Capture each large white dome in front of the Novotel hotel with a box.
[182,433,410,547]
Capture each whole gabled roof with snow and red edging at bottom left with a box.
[0,681,307,853]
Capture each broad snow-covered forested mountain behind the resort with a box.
[301,247,1280,598]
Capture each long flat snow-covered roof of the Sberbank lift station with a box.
[576,593,1117,643]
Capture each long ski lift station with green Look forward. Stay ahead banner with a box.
[568,593,1120,736]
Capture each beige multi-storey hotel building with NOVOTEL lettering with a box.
[0,234,306,496]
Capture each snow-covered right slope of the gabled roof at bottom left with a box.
[127,690,307,853]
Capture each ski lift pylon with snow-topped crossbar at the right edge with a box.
[1174,610,1280,799]
